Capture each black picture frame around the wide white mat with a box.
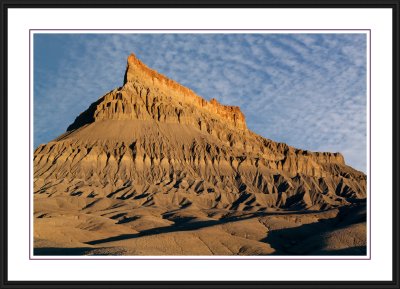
[0,0,400,288]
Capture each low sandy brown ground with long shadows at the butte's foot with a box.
[34,196,366,256]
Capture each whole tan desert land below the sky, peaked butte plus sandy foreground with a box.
[34,54,366,255]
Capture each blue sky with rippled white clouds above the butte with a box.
[34,34,367,172]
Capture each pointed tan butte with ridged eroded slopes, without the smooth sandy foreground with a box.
[34,54,366,211]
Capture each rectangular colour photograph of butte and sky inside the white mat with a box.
[30,29,370,255]
